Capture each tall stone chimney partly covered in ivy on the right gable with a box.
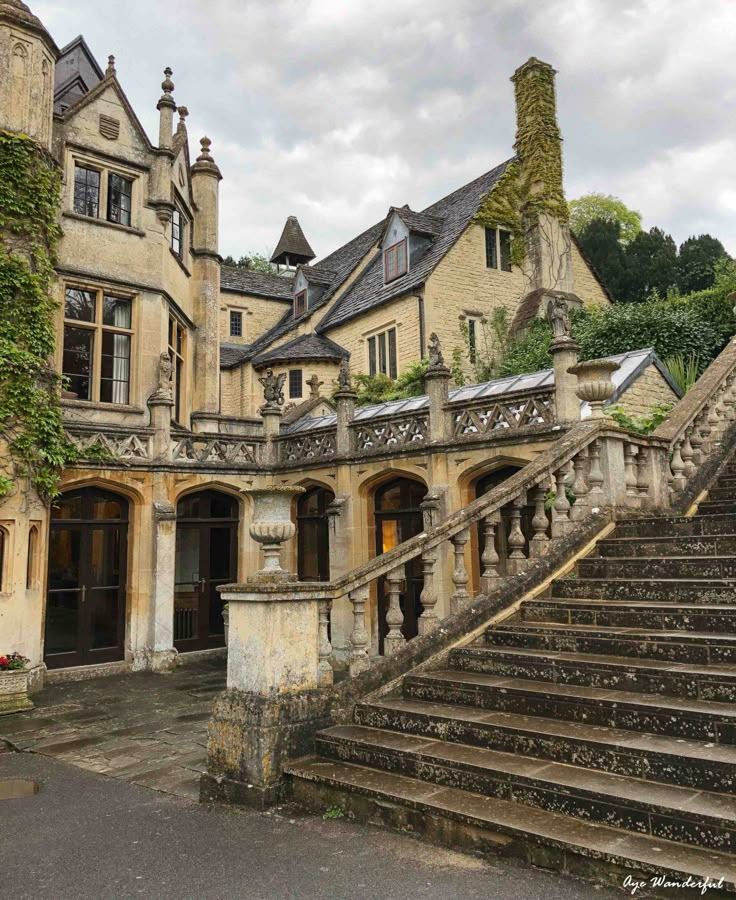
[511,57,573,293]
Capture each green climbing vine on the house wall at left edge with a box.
[0,131,79,501]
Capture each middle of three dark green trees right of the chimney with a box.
[617,228,677,303]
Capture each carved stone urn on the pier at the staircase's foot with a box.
[243,485,305,581]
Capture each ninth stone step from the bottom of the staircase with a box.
[577,556,736,580]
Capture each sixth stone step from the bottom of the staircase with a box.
[485,623,736,665]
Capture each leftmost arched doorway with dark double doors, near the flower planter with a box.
[44,487,130,669]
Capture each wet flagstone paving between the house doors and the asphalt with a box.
[0,659,225,799]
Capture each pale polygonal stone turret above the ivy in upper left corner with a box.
[0,0,59,150]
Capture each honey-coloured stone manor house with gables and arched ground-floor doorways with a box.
[0,0,677,684]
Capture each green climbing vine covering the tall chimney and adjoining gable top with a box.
[474,60,569,266]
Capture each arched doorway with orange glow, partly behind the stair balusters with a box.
[374,478,427,653]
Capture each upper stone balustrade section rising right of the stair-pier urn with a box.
[654,338,736,495]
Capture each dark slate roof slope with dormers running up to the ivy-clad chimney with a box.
[317,160,511,331]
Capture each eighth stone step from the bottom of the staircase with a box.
[551,578,736,604]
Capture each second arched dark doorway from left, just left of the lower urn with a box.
[174,491,240,653]
